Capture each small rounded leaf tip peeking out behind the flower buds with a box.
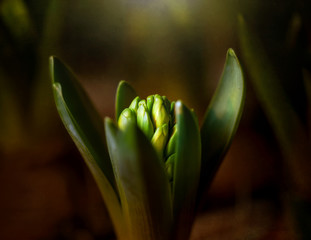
[116,81,137,121]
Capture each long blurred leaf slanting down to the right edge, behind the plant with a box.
[238,16,311,195]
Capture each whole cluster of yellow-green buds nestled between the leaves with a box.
[118,94,177,180]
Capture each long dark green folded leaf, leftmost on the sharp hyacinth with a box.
[50,57,122,236]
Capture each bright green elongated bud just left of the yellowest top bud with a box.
[137,100,154,140]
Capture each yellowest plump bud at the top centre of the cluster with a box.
[152,95,170,128]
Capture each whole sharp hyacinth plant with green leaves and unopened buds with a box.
[50,49,245,240]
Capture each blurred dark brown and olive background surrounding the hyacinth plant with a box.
[0,0,311,240]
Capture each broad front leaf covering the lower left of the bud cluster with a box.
[105,119,172,240]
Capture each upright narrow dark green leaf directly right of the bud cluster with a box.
[173,101,201,240]
